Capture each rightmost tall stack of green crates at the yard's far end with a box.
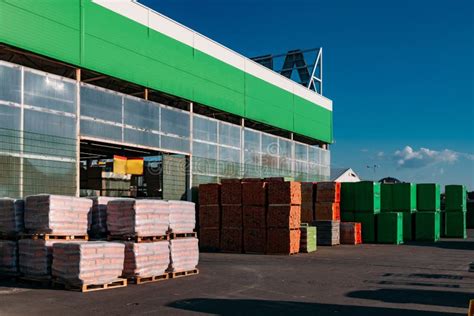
[444,185,467,238]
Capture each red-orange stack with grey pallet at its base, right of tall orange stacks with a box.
[313,182,341,246]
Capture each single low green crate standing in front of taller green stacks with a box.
[377,212,403,245]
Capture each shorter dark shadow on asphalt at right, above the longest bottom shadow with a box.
[346,289,474,311]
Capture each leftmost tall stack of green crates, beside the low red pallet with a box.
[352,181,381,243]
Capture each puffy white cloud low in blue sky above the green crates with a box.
[393,146,466,172]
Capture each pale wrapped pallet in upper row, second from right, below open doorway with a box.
[107,199,170,236]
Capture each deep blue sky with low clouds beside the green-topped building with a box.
[141,0,474,190]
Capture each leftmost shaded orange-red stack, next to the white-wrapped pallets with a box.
[198,183,221,251]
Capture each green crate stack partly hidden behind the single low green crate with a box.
[381,183,416,241]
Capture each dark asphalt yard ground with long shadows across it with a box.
[0,230,474,316]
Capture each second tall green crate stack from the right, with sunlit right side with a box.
[415,183,441,241]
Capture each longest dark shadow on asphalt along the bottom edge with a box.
[167,298,460,316]
